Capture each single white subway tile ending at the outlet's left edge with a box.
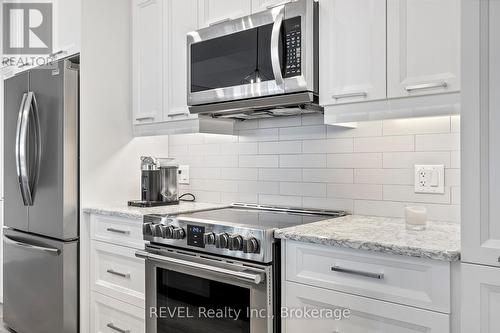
[354,169,415,185]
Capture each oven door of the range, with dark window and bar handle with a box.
[136,250,273,333]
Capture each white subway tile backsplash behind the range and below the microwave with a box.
[169,116,460,222]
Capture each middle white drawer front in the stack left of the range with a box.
[90,241,145,308]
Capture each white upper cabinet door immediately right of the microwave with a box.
[319,0,386,105]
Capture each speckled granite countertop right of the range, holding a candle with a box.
[274,215,460,261]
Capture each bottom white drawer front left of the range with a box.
[90,292,146,333]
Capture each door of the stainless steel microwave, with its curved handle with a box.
[187,5,285,106]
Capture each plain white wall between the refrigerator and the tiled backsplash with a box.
[81,0,168,207]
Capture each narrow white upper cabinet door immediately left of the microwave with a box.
[164,0,198,120]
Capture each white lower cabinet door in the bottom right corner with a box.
[461,262,500,333]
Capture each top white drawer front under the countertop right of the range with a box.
[286,241,451,313]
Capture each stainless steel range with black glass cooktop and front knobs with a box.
[136,204,345,333]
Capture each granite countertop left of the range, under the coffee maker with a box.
[83,201,227,219]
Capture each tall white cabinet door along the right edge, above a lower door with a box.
[461,0,500,266]
